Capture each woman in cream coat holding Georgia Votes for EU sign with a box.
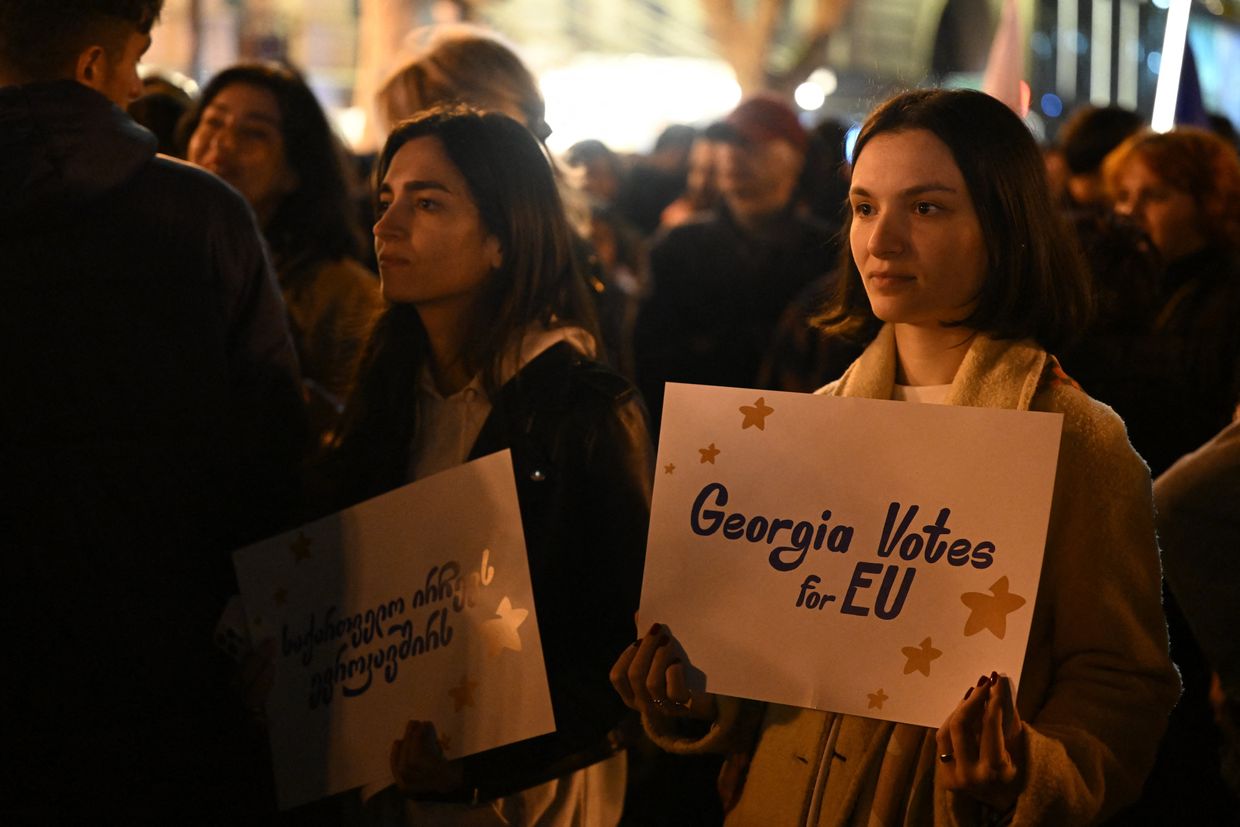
[611,89,1179,826]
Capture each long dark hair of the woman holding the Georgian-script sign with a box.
[335,107,598,487]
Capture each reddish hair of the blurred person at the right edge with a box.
[1102,126,1240,250]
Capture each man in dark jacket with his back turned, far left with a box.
[0,0,304,823]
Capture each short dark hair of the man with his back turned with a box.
[0,0,164,82]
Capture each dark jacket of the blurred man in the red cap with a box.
[634,210,836,433]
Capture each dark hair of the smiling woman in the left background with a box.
[177,63,361,270]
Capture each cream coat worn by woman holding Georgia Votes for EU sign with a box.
[645,326,1179,827]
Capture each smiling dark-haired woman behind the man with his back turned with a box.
[179,63,382,436]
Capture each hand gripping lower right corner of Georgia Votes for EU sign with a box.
[935,672,1024,812]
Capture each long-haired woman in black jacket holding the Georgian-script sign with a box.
[324,108,652,825]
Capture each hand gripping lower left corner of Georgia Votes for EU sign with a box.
[610,624,715,720]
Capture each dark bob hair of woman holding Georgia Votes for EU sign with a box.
[815,89,1091,350]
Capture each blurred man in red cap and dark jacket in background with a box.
[634,95,837,431]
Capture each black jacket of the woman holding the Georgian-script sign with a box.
[329,342,653,798]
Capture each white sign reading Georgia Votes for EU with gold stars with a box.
[641,384,1063,727]
